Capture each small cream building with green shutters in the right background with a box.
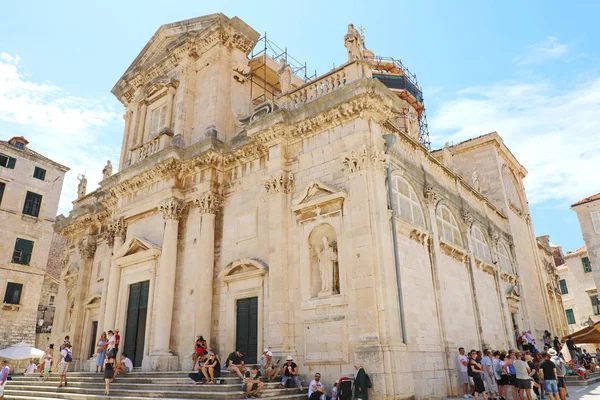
[557,246,600,332]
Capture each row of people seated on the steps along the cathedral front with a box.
[188,335,371,400]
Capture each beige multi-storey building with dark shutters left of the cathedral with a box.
[0,137,69,348]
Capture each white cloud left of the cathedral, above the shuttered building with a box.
[0,53,122,214]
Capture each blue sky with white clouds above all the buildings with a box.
[0,0,600,250]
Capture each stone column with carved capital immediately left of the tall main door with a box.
[98,218,127,332]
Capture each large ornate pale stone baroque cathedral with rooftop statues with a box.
[52,14,565,399]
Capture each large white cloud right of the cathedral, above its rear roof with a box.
[430,78,600,203]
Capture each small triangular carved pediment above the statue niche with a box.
[291,181,348,222]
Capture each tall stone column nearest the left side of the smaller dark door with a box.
[193,191,222,346]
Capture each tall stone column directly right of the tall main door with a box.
[148,197,184,370]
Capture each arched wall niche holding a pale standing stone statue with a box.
[309,224,340,297]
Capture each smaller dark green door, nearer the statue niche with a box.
[235,297,258,364]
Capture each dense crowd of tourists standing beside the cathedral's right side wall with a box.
[457,326,600,400]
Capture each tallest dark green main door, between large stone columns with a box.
[122,281,150,367]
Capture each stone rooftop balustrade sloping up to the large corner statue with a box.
[277,60,372,109]
